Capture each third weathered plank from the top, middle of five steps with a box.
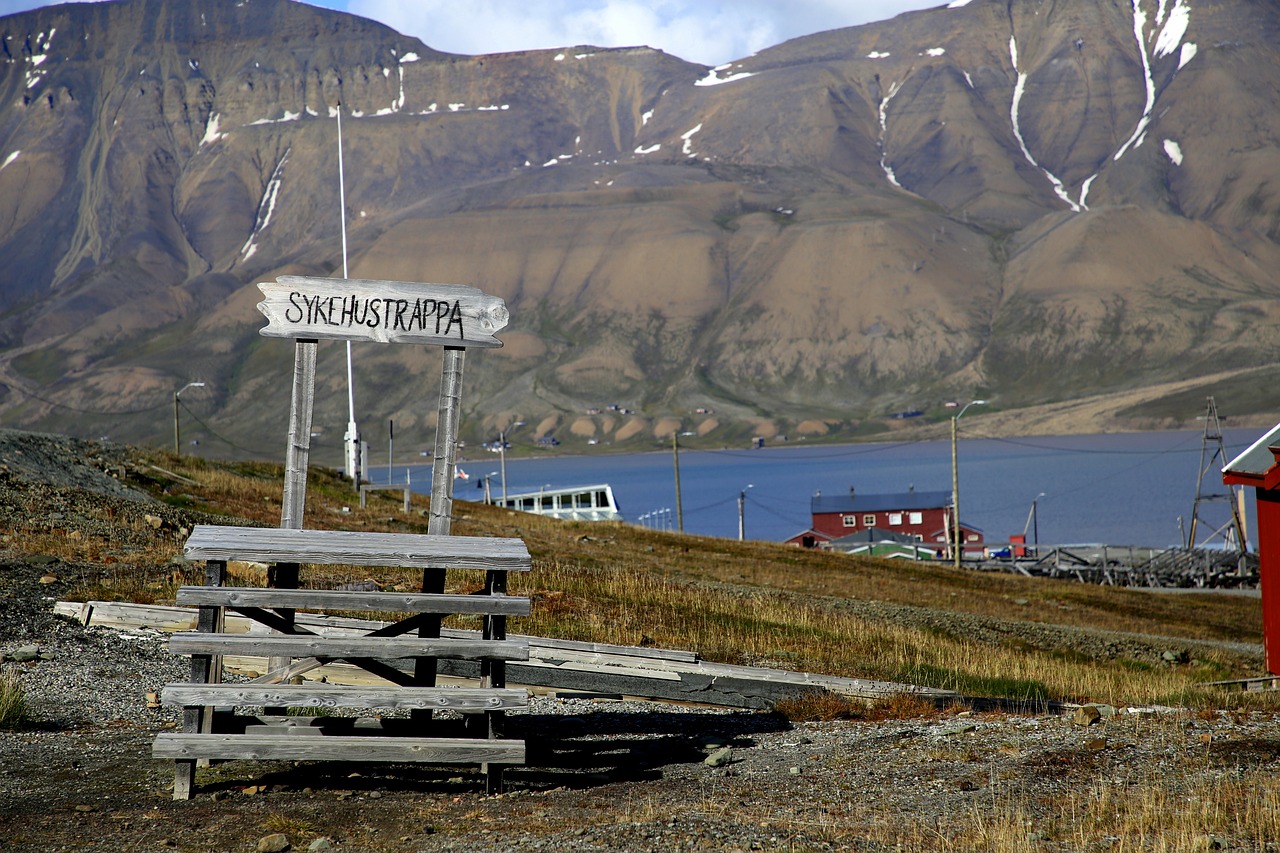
[169,631,529,661]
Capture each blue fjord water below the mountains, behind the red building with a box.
[404,424,1263,547]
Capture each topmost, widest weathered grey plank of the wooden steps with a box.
[183,524,532,571]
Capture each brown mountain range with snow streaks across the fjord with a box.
[0,0,1280,462]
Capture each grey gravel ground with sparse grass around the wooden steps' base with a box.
[0,434,1280,853]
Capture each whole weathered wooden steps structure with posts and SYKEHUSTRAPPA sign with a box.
[152,277,531,799]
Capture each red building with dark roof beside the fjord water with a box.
[787,489,984,555]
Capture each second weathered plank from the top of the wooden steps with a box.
[177,587,530,616]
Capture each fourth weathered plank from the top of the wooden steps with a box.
[161,684,529,712]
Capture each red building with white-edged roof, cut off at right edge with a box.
[1222,424,1280,675]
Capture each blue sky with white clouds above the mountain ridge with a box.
[0,0,946,65]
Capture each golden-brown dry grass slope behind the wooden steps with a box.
[10,452,1270,707]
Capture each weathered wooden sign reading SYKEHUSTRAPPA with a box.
[257,275,511,347]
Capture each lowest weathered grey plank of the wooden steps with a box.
[151,731,525,765]
